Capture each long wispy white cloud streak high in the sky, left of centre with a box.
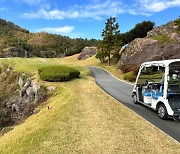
[22,0,125,20]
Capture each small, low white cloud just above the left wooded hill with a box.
[36,26,74,34]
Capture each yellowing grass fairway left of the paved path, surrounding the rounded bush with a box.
[0,56,180,154]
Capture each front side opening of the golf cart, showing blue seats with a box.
[137,63,165,102]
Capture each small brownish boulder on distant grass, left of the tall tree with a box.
[78,47,97,60]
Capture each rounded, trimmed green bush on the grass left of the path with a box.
[38,65,80,82]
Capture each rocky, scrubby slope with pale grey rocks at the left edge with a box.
[0,68,47,126]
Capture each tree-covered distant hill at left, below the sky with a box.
[0,19,97,57]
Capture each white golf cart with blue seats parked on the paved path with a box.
[132,59,180,121]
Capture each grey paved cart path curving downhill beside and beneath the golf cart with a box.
[88,67,180,142]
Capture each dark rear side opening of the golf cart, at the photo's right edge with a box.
[167,62,180,95]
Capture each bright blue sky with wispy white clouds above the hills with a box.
[0,0,180,39]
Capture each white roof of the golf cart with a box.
[141,59,180,66]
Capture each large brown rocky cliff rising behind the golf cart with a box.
[118,19,180,72]
